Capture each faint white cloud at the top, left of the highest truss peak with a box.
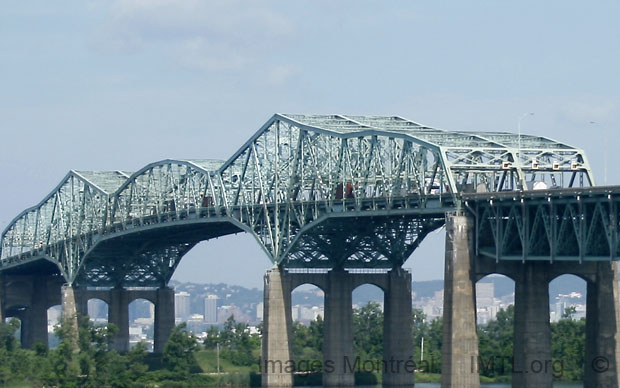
[97,0,293,71]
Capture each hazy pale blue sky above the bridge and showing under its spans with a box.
[0,0,620,286]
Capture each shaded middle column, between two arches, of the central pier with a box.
[323,269,355,387]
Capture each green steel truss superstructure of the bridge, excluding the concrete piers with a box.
[0,114,620,287]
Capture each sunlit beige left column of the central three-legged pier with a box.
[261,268,293,387]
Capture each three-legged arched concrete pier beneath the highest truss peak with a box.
[261,268,414,387]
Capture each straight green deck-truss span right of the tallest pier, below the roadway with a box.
[465,187,620,262]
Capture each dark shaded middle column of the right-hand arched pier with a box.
[512,262,553,388]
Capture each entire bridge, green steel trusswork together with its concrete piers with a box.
[0,114,620,388]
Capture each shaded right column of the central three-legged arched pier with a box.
[383,267,414,386]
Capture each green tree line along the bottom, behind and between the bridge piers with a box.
[0,302,585,388]
